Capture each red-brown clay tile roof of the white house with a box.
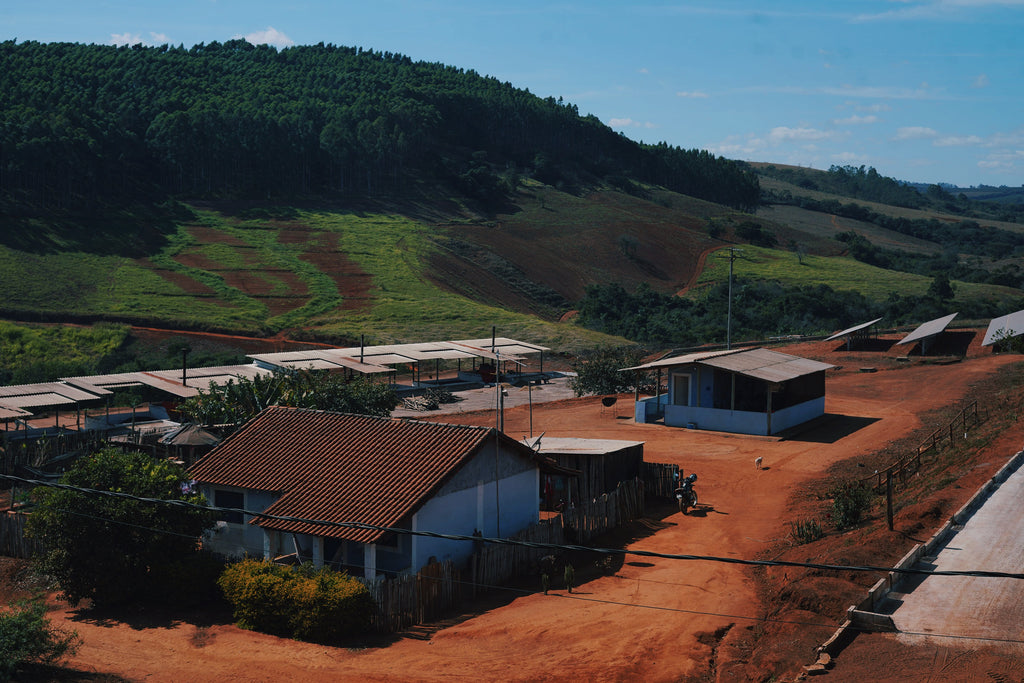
[190,408,534,543]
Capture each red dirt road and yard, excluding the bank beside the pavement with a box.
[28,335,1020,681]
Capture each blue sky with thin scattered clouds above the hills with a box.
[0,0,1024,186]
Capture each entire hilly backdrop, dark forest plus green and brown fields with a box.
[0,41,1024,350]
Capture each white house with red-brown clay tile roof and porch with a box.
[189,407,544,579]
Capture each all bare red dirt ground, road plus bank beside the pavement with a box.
[8,337,1022,681]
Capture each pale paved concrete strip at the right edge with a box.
[889,468,1024,642]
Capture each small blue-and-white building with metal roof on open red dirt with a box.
[625,348,835,436]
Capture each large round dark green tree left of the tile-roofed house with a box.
[28,449,215,605]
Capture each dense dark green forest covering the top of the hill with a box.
[0,40,759,213]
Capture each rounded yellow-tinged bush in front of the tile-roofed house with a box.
[217,559,377,642]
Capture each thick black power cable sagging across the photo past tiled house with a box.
[8,474,1024,579]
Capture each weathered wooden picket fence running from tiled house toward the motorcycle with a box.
[364,479,645,633]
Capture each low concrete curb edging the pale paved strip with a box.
[816,451,1024,657]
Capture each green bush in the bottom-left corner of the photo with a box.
[0,597,81,681]
